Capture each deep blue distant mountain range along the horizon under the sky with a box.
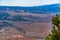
[0,4,60,14]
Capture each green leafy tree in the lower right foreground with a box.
[46,14,60,40]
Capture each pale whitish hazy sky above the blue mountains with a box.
[0,0,60,6]
